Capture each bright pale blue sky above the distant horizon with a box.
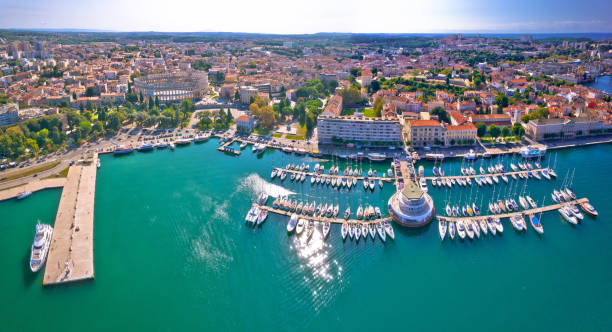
[0,0,612,33]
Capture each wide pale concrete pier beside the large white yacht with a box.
[43,154,98,285]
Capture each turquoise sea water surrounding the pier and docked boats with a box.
[0,140,612,331]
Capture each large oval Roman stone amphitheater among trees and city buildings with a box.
[134,70,208,102]
